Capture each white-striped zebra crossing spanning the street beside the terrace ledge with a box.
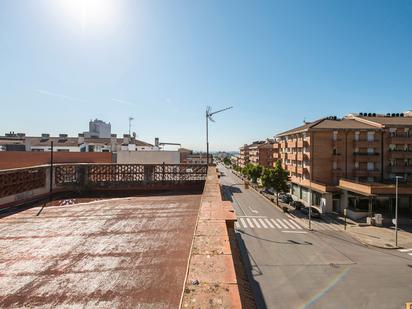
[236,217,303,230]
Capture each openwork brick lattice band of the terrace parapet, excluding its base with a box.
[0,164,208,198]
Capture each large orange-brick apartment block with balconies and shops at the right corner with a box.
[273,112,412,218]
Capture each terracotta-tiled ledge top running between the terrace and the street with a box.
[180,167,242,308]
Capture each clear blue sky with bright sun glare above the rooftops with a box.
[0,0,412,151]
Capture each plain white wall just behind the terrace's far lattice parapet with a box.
[117,150,180,164]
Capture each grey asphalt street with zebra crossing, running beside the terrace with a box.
[219,162,412,309]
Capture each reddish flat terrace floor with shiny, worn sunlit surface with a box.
[0,195,201,308]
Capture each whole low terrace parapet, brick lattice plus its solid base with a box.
[0,164,207,207]
